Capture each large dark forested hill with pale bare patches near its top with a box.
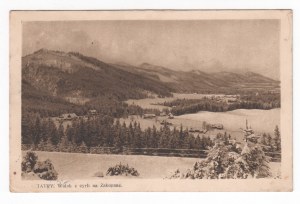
[22,49,171,100]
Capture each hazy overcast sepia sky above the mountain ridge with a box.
[23,20,280,79]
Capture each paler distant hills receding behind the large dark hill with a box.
[114,63,280,93]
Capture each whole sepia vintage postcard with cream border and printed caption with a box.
[10,10,293,192]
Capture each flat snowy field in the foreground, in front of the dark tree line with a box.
[23,151,280,180]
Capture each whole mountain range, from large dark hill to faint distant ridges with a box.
[22,49,280,113]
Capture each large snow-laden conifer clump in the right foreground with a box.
[171,131,271,179]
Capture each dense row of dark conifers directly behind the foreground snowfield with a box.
[22,114,213,150]
